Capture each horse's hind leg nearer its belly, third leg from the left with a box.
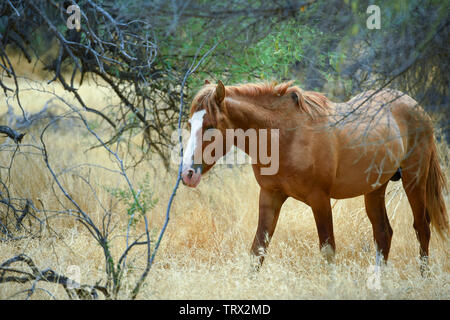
[364,183,393,266]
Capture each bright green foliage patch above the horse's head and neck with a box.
[188,20,338,91]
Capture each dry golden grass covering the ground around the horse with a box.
[0,57,450,299]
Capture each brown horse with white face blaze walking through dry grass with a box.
[182,81,448,269]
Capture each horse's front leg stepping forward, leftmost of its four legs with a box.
[251,188,287,270]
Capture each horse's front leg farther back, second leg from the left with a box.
[307,191,336,262]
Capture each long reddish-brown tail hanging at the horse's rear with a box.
[426,141,449,239]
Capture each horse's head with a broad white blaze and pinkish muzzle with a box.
[181,80,231,188]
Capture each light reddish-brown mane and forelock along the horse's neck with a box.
[190,81,330,118]
